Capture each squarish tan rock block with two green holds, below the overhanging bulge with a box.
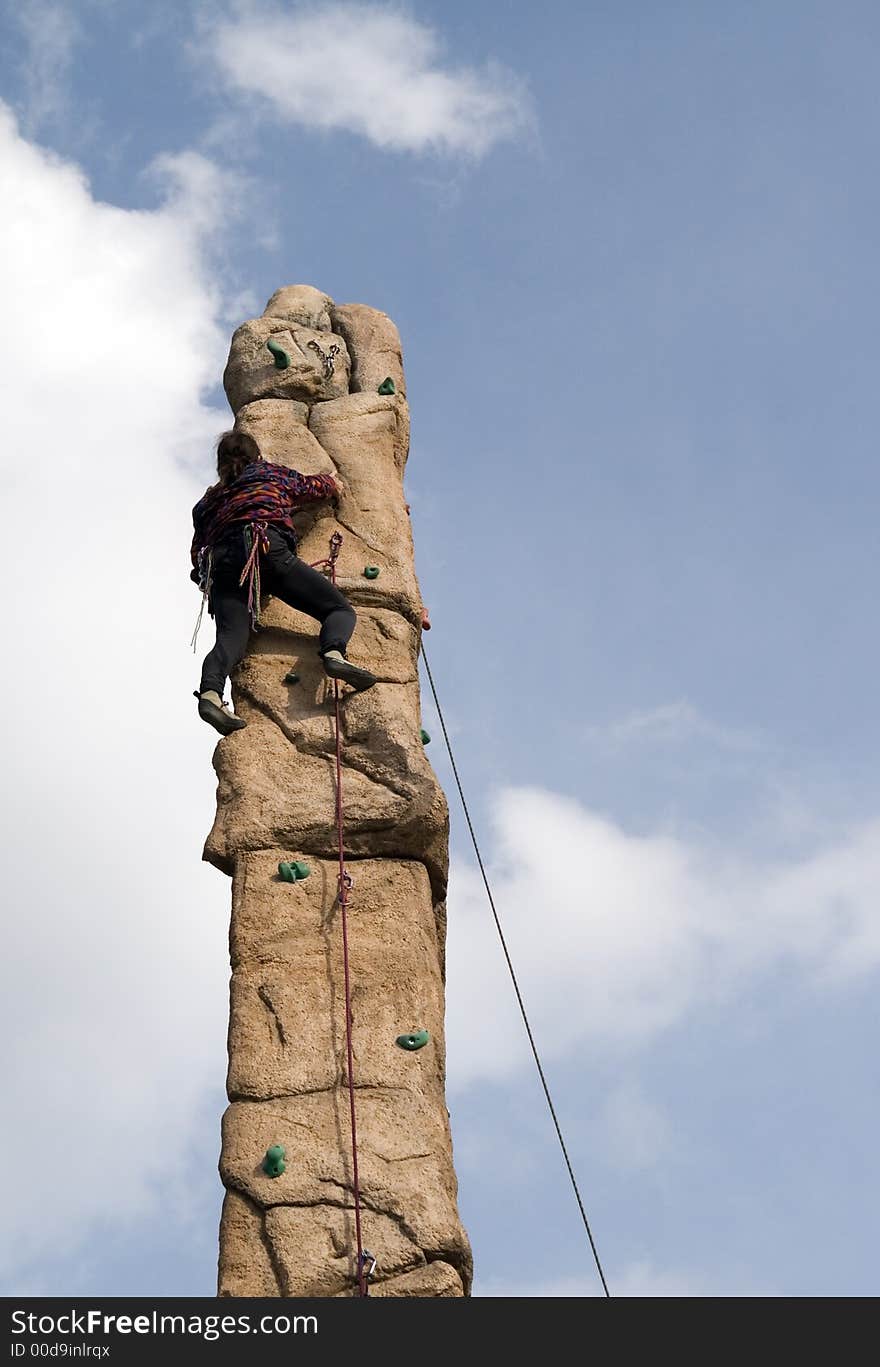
[228,849,445,1093]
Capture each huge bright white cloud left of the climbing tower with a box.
[0,105,230,1292]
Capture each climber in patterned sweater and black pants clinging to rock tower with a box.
[190,431,376,735]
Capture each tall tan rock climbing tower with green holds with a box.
[205,286,471,1296]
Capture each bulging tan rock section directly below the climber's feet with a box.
[205,612,448,897]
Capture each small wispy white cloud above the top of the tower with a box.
[200,0,530,157]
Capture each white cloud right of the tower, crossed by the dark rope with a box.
[447,789,880,1087]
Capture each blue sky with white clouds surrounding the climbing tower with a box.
[0,0,880,1296]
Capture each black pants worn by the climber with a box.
[198,526,357,697]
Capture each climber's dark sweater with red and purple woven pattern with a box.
[190,461,336,571]
